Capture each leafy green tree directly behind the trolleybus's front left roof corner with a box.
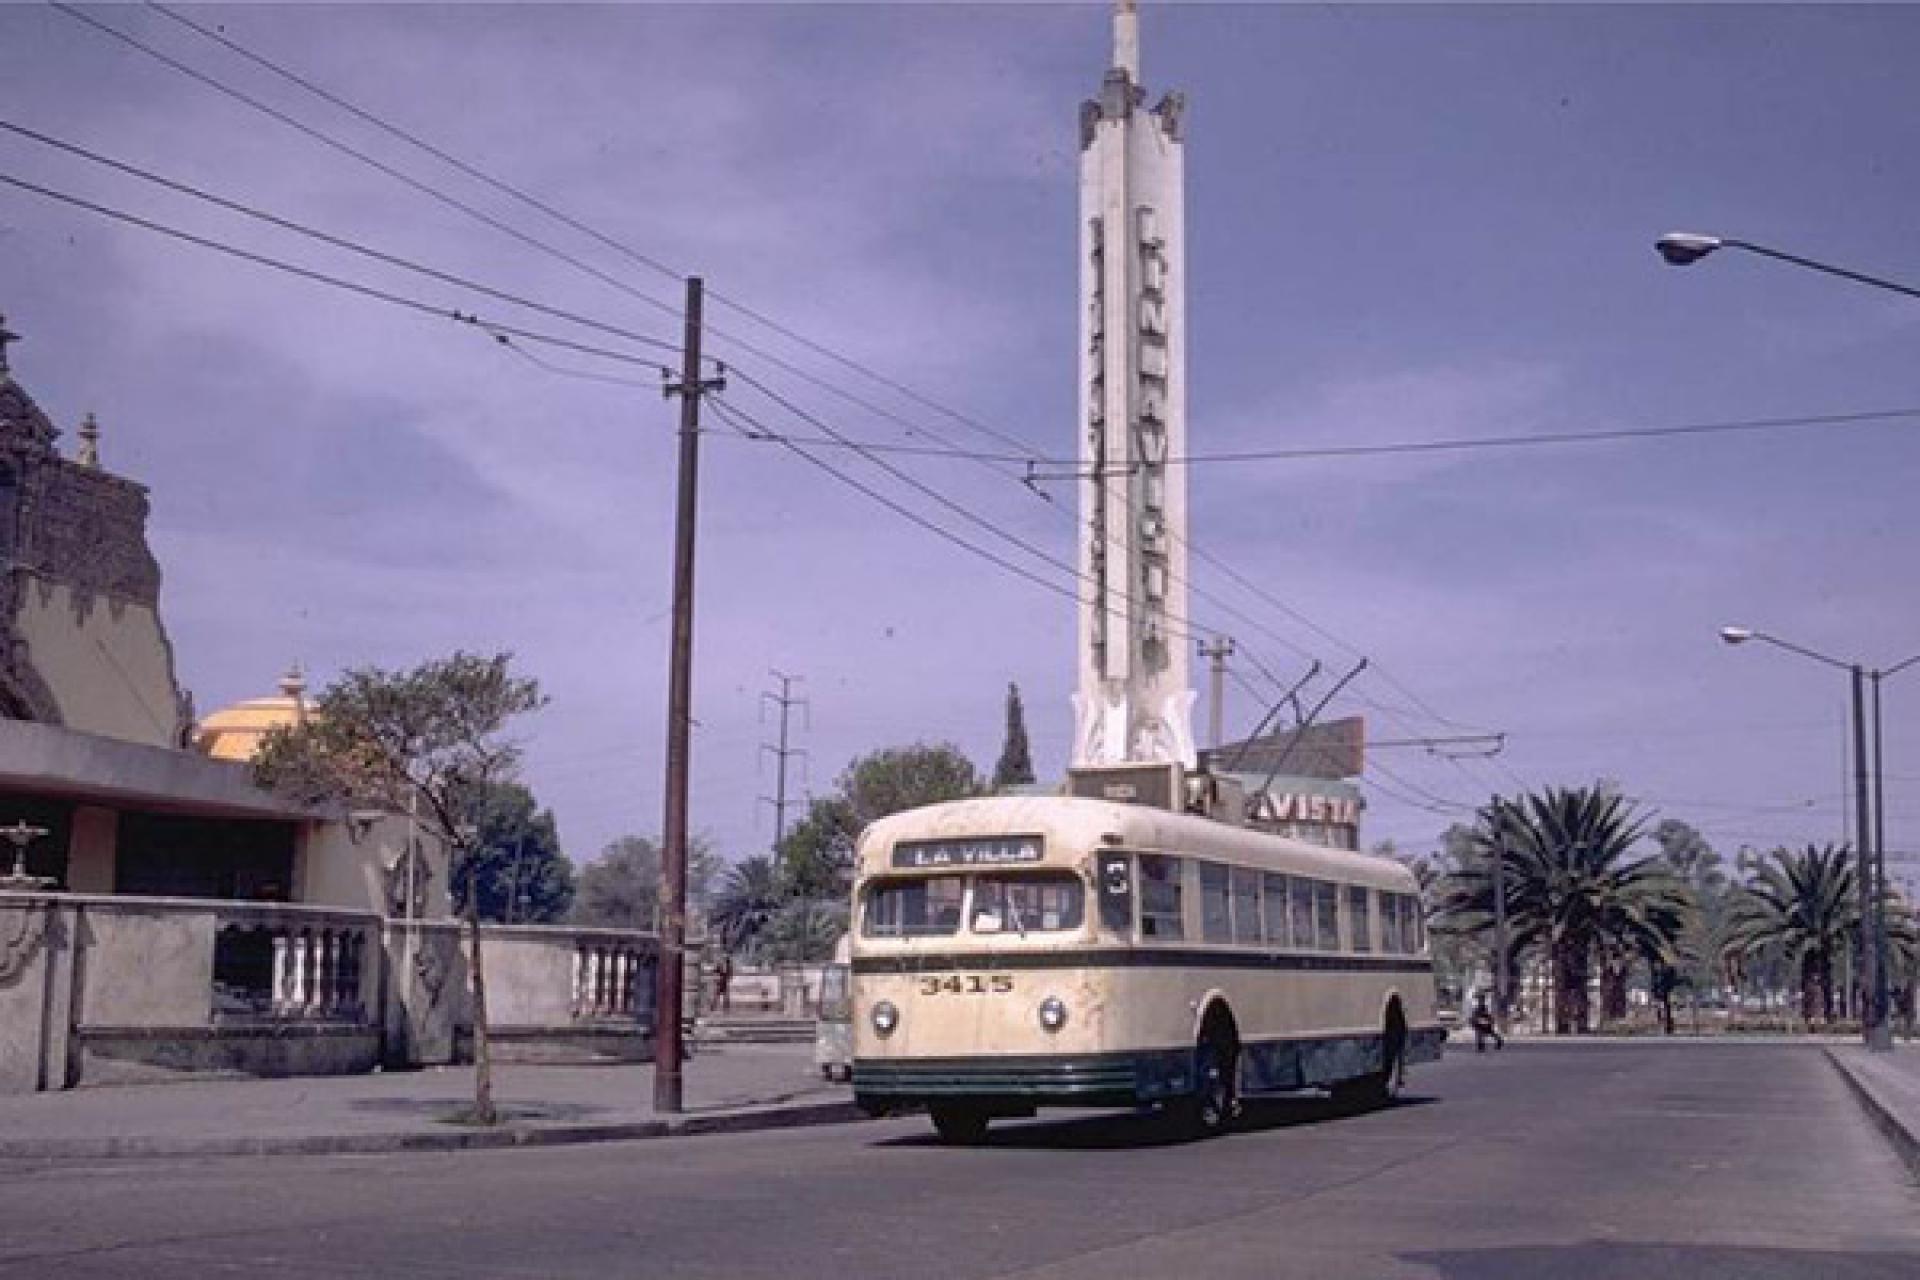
[776,743,981,898]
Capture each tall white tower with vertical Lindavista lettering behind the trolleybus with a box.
[1073,0,1194,768]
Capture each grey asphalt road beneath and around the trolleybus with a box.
[0,1044,1920,1280]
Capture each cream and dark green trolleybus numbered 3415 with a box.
[851,796,1446,1142]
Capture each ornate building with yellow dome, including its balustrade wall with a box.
[0,320,657,1094]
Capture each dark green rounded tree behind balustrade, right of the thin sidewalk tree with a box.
[453,783,574,925]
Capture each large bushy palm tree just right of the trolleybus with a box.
[1446,787,1695,1032]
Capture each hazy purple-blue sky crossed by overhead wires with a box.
[0,6,1920,890]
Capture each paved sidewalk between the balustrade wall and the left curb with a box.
[0,1044,860,1159]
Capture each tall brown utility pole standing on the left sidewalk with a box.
[653,276,726,1115]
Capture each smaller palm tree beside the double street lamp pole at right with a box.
[1726,844,1850,1023]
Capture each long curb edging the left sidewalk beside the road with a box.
[0,1102,868,1161]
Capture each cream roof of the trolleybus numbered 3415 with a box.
[854,796,1419,892]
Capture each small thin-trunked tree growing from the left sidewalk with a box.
[253,652,545,1125]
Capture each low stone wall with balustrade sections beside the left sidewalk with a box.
[0,892,657,1094]
